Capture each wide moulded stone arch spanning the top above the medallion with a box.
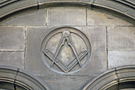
[0,0,135,20]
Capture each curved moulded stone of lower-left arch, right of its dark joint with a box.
[15,69,50,90]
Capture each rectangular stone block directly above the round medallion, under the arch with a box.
[47,7,86,25]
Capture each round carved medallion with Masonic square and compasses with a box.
[41,27,91,74]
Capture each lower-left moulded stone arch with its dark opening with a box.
[0,66,49,90]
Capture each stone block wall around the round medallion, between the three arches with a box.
[0,6,135,90]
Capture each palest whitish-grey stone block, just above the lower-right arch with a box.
[108,51,135,69]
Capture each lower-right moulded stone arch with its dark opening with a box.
[83,66,135,90]
